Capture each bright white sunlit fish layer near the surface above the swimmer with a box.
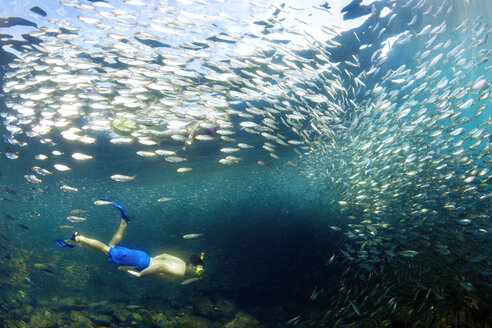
[4,1,354,177]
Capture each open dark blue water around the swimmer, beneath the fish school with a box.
[0,127,343,322]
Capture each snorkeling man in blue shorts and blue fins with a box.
[55,200,204,282]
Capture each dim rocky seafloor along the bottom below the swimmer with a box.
[2,297,271,328]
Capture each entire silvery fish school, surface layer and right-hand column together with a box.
[1,0,492,327]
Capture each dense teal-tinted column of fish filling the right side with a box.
[302,1,492,327]
